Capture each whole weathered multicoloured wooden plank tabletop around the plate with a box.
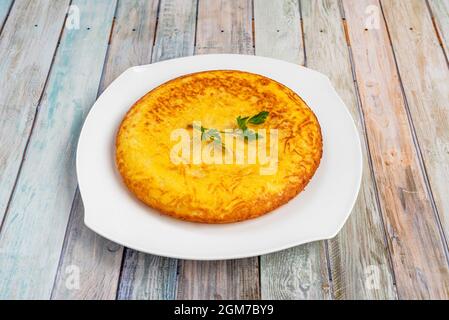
[0,0,449,299]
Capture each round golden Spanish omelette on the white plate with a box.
[116,70,322,223]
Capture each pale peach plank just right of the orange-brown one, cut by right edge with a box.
[382,0,449,268]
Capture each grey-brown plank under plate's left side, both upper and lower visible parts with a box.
[53,0,158,299]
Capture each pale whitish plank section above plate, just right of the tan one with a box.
[254,0,304,65]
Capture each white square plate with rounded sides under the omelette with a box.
[76,54,362,260]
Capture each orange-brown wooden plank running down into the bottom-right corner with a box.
[343,0,449,299]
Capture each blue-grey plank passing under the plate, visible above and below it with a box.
[118,0,197,300]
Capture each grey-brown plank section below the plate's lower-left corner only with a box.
[52,190,123,300]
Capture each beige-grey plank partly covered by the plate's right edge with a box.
[301,0,396,299]
